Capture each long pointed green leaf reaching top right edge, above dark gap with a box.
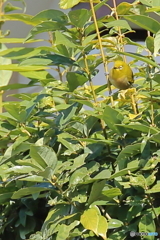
[124,15,160,33]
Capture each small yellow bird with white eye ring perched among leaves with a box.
[109,60,134,90]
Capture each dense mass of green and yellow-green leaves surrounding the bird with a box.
[0,0,160,240]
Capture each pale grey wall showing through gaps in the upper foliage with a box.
[3,0,160,98]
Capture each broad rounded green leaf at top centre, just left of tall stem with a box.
[68,9,90,28]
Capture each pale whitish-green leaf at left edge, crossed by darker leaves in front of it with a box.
[0,44,12,86]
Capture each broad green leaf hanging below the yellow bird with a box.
[103,106,124,135]
